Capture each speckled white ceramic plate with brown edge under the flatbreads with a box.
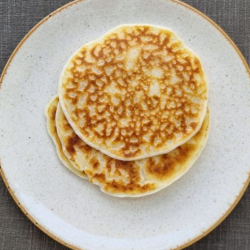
[0,0,250,250]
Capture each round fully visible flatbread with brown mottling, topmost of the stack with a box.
[59,25,207,161]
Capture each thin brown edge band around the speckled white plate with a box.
[0,0,250,250]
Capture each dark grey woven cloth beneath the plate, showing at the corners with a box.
[0,0,250,250]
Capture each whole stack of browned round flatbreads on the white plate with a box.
[46,25,209,197]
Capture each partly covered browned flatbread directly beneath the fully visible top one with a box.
[46,96,209,197]
